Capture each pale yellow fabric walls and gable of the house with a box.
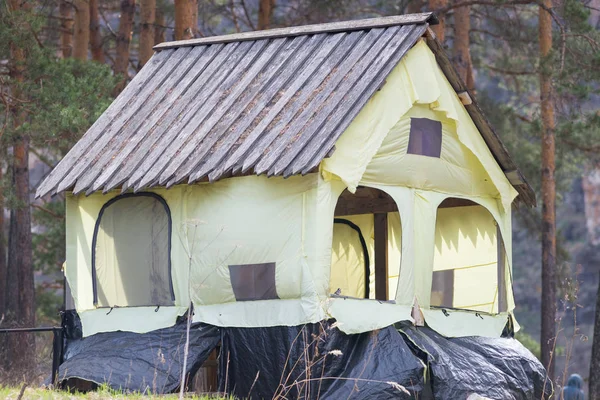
[65,38,516,336]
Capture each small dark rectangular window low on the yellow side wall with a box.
[229,262,279,301]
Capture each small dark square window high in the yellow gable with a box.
[407,118,442,158]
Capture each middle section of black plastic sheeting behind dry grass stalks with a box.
[219,322,424,399]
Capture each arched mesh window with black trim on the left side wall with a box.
[92,193,175,307]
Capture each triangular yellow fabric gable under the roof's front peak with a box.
[321,41,517,210]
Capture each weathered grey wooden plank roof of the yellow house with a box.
[36,13,536,206]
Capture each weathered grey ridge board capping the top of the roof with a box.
[154,12,438,51]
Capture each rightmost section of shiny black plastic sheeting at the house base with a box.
[400,324,552,400]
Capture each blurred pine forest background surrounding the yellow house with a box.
[0,0,600,398]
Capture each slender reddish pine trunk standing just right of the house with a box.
[539,0,556,379]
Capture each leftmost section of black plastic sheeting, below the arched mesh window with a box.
[59,322,220,393]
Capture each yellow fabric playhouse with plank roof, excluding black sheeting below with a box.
[37,14,548,396]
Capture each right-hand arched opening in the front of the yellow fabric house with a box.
[430,198,507,314]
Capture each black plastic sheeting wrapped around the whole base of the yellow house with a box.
[54,321,552,400]
